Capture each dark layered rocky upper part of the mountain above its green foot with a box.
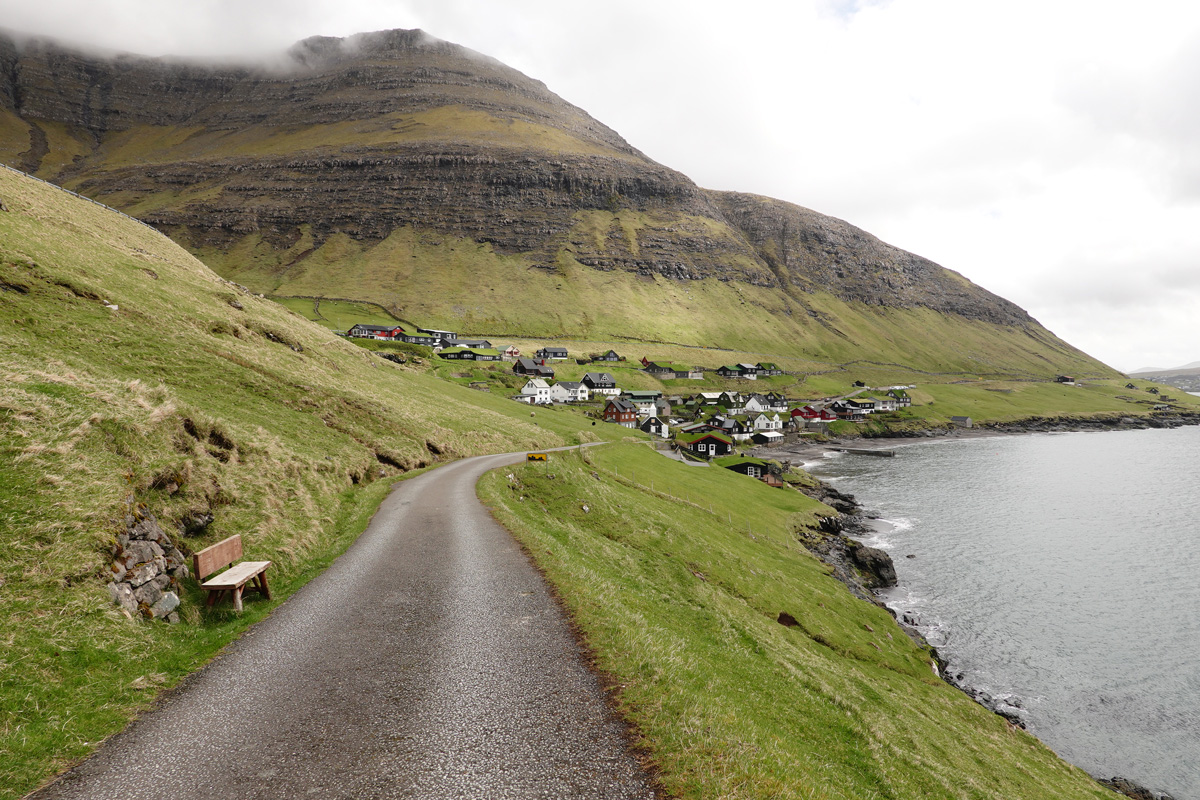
[0,30,1036,326]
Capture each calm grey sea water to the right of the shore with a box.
[808,427,1200,800]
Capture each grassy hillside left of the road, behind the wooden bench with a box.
[0,169,628,798]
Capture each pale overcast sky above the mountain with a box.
[0,0,1200,369]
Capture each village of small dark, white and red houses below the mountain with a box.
[346,324,916,486]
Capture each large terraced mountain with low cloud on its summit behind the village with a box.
[0,30,1115,378]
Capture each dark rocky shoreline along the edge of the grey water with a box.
[760,413,1200,800]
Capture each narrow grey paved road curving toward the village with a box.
[34,455,653,800]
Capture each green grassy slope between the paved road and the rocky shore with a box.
[480,445,1111,800]
